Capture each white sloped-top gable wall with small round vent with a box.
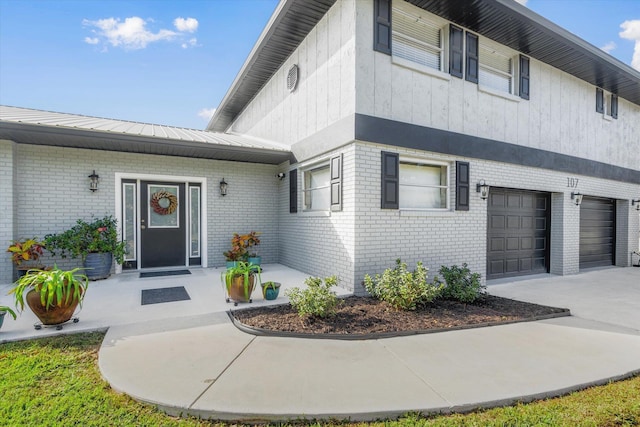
[231,0,356,144]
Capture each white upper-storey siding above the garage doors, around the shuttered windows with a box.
[356,1,640,170]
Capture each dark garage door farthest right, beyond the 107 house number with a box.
[580,197,616,269]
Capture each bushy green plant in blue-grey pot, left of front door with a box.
[45,216,126,280]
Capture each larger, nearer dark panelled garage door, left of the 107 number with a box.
[487,187,551,279]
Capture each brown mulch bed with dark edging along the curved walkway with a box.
[231,295,569,335]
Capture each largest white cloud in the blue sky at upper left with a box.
[82,16,177,49]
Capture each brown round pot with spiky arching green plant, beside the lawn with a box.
[9,266,89,325]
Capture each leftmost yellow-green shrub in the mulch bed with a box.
[285,276,340,317]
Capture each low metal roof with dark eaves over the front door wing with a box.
[0,105,290,164]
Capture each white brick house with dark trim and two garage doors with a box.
[0,0,640,293]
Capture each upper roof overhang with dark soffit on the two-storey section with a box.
[207,0,640,132]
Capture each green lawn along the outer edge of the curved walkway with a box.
[0,333,640,427]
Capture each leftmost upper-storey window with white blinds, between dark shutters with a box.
[391,2,443,71]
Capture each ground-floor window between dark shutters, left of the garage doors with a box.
[398,160,449,209]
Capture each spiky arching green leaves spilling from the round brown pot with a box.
[9,266,89,311]
